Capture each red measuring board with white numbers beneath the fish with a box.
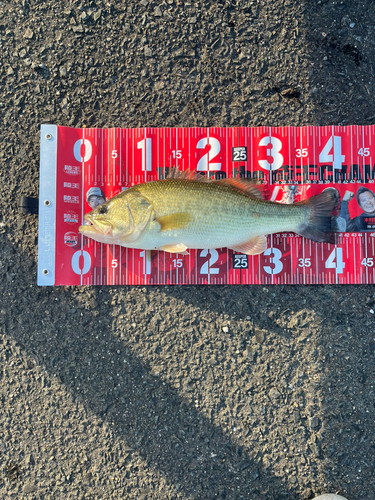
[38,125,375,285]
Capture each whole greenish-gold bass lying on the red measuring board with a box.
[79,169,337,255]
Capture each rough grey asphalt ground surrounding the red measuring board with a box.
[0,0,375,500]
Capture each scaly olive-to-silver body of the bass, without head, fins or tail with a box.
[132,179,307,248]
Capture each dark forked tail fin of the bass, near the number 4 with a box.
[296,188,339,243]
